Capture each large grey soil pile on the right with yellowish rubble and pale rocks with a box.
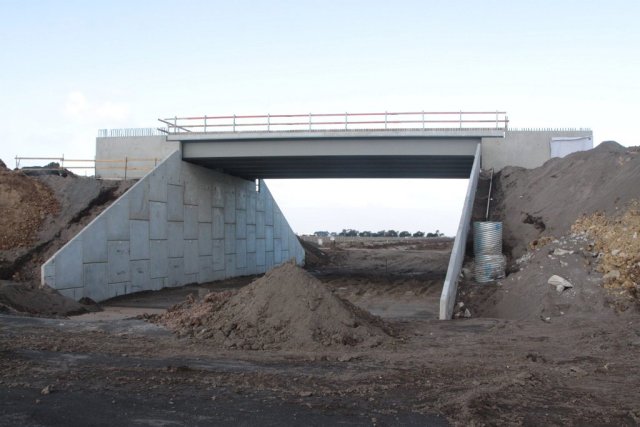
[457,142,640,322]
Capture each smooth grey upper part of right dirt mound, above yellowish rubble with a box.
[491,141,640,259]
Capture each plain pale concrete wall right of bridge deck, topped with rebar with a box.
[482,130,593,171]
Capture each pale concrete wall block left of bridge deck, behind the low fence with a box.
[96,135,180,179]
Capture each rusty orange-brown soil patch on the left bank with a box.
[0,169,60,251]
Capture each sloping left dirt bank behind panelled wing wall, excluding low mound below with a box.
[0,171,133,281]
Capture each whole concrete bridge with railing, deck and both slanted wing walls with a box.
[42,112,590,319]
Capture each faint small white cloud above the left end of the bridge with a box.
[63,91,131,123]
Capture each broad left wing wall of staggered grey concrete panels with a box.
[42,151,304,301]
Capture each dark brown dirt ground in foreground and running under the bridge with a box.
[0,241,640,426]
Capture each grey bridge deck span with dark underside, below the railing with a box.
[172,129,504,179]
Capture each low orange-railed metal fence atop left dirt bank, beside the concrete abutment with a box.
[15,156,162,179]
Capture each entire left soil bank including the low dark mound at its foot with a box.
[0,161,133,316]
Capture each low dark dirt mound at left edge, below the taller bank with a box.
[0,280,94,316]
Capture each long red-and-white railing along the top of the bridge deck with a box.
[158,111,509,134]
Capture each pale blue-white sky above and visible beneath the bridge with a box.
[0,0,640,235]
